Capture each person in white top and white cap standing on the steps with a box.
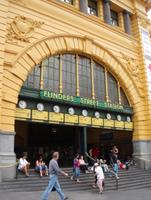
[94,163,104,194]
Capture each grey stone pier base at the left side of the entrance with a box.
[0,131,16,180]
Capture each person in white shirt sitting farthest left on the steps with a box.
[18,153,30,176]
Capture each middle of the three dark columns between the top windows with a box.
[103,0,111,24]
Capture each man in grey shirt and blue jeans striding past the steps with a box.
[41,152,68,200]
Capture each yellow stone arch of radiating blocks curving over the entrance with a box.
[1,35,141,179]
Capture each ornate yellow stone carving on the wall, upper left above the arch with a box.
[7,16,43,42]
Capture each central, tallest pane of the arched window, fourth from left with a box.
[79,56,92,98]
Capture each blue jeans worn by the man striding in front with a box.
[41,174,65,200]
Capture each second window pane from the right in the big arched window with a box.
[108,73,119,104]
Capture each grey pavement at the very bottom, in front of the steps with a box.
[0,188,151,200]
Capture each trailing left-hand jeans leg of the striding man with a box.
[41,175,57,200]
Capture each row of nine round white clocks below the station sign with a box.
[18,100,131,122]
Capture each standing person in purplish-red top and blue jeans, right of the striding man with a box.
[71,154,80,183]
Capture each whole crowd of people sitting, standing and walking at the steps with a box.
[18,146,134,200]
